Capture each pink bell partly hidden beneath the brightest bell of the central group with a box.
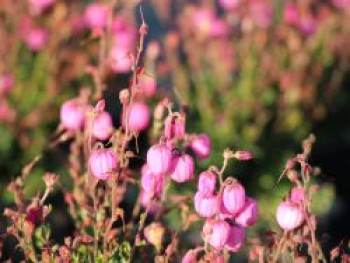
[141,164,164,195]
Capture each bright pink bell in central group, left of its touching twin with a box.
[147,144,172,175]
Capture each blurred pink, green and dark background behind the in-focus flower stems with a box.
[0,0,350,260]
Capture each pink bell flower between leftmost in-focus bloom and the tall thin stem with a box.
[92,111,113,140]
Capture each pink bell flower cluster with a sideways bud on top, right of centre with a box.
[183,150,258,262]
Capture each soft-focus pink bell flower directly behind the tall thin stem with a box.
[125,102,151,132]
